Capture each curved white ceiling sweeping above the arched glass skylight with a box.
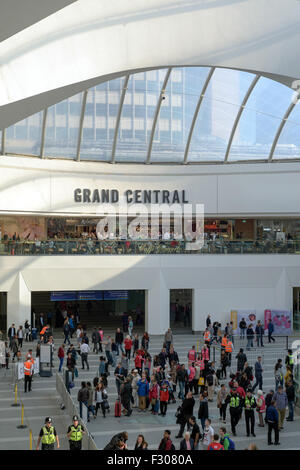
[0,0,300,127]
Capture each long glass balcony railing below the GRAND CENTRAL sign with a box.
[0,239,300,256]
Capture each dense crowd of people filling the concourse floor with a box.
[6,314,295,450]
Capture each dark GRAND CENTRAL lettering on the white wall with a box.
[74,188,189,204]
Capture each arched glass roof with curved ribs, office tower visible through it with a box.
[0,67,300,164]
